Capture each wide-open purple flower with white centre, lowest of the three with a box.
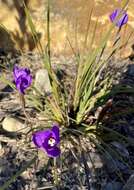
[32,124,60,157]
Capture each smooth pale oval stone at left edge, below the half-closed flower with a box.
[2,116,28,133]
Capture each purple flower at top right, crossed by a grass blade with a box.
[109,9,128,28]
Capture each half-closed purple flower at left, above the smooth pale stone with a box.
[13,65,32,94]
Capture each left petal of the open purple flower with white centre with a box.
[32,130,52,148]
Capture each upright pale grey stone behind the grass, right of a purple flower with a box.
[34,69,51,95]
